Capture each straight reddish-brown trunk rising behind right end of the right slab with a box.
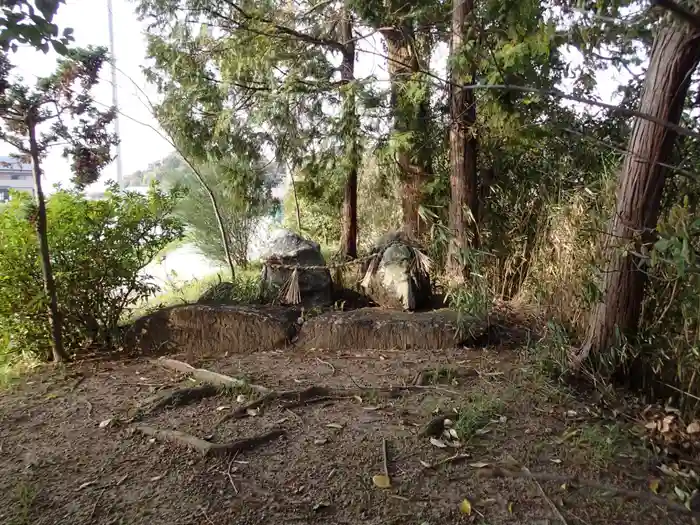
[445,0,479,283]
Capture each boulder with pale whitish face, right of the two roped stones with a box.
[362,232,432,311]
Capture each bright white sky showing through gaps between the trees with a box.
[0,0,627,190]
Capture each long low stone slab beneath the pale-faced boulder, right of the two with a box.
[295,308,488,350]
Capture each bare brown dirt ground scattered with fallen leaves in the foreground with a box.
[0,348,691,525]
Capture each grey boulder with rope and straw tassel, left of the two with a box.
[262,229,333,308]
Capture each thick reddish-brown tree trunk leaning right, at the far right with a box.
[572,20,700,373]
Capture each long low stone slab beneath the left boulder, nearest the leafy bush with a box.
[126,304,300,355]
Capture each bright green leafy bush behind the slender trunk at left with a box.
[0,185,184,356]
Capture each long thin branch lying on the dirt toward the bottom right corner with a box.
[468,466,700,517]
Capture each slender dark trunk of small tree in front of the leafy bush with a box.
[28,120,68,363]
